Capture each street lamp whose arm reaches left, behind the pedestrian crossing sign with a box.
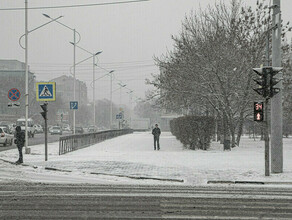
[43,14,81,134]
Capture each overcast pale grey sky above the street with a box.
[0,0,292,103]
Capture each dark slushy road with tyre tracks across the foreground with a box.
[0,182,292,219]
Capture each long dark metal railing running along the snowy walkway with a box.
[59,129,133,155]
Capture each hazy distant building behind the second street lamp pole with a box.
[50,75,88,107]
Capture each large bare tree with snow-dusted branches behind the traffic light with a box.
[149,0,285,147]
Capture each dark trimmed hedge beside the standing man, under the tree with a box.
[170,116,215,150]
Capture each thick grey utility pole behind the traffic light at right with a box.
[271,0,283,173]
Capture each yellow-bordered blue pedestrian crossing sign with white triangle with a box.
[36,82,56,101]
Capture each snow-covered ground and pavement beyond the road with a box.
[0,132,292,185]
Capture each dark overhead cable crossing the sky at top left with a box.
[0,0,150,11]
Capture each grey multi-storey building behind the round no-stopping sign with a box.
[0,60,35,121]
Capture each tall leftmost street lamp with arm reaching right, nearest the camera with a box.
[18,9,63,153]
